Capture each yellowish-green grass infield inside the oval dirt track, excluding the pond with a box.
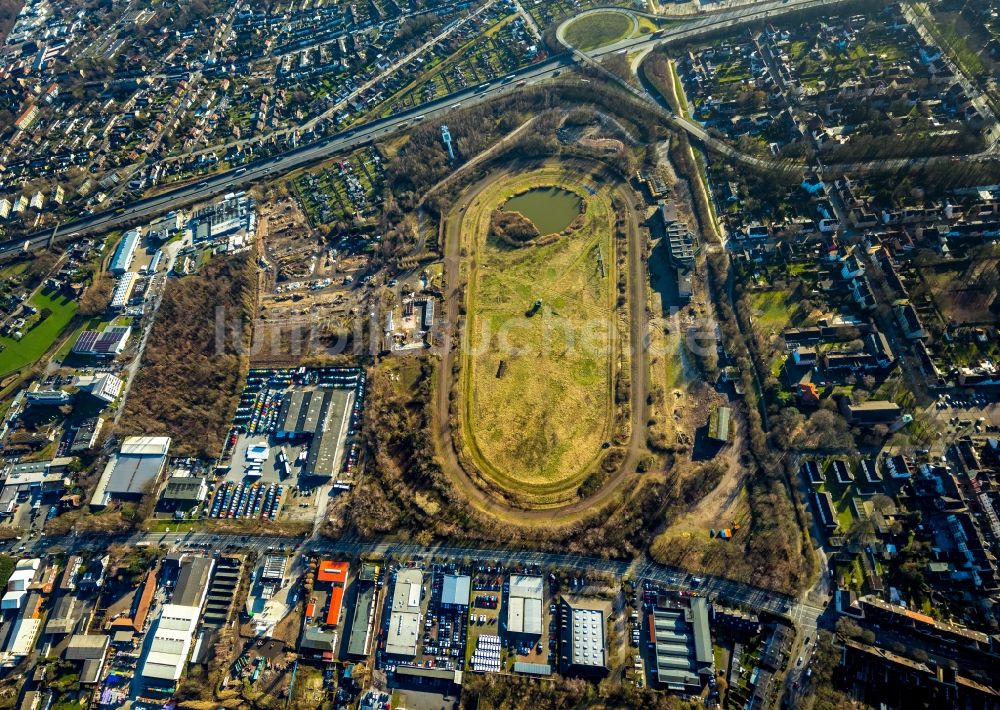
[462,167,618,496]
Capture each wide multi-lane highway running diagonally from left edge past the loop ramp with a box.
[0,0,843,257]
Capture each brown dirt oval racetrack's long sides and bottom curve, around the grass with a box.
[434,163,648,526]
